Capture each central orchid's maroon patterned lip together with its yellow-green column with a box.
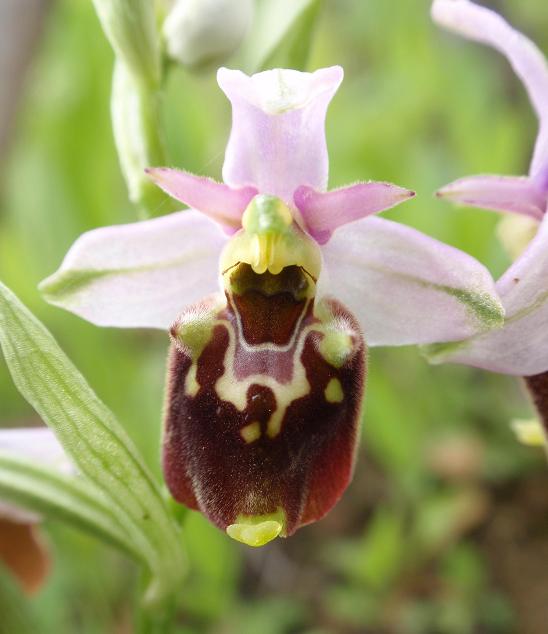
[164,195,365,546]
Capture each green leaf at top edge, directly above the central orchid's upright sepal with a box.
[235,0,322,72]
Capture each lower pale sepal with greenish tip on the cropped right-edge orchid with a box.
[432,212,548,376]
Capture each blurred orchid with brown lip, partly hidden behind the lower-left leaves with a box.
[0,428,74,593]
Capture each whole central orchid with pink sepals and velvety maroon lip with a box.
[42,67,502,546]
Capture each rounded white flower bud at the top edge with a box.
[163,0,253,68]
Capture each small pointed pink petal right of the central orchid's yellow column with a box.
[293,182,415,244]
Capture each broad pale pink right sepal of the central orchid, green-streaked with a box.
[320,218,503,346]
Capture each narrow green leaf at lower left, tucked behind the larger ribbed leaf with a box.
[0,450,141,560]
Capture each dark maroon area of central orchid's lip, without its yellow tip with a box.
[163,264,365,535]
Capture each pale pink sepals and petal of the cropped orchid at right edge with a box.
[432,0,548,376]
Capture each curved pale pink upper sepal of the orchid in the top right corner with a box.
[432,0,548,181]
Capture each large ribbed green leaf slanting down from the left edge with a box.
[0,283,185,605]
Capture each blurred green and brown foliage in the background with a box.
[0,0,548,634]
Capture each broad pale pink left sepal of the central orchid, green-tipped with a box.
[40,210,227,329]
